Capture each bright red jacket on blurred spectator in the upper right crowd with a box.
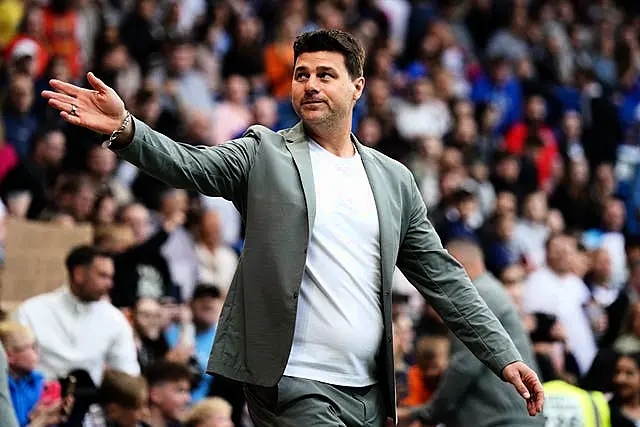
[505,123,558,187]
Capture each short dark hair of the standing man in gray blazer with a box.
[293,29,365,79]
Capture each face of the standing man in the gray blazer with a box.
[291,51,364,124]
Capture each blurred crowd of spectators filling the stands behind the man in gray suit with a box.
[0,0,640,427]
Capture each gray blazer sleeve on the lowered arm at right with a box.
[396,179,522,378]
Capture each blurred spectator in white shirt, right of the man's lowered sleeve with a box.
[523,235,596,373]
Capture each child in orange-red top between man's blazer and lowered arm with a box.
[401,335,450,406]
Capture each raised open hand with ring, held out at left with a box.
[42,73,126,134]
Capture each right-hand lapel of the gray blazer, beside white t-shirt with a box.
[352,136,394,291]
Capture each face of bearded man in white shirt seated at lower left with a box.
[74,257,114,302]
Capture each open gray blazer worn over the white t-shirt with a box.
[118,119,521,418]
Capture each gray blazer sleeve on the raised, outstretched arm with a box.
[116,118,258,201]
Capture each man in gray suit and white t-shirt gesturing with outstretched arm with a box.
[43,30,543,427]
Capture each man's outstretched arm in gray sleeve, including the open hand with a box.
[42,73,258,201]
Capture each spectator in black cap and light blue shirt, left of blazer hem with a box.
[165,284,224,403]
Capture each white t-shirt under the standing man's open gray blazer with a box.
[284,142,383,387]
